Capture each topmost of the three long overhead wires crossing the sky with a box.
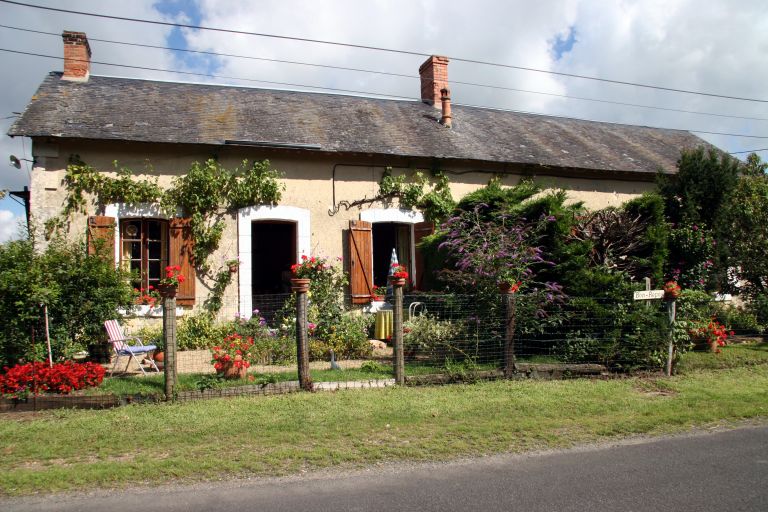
[0,0,768,103]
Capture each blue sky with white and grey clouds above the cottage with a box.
[0,0,768,242]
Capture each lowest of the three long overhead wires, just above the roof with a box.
[0,48,768,139]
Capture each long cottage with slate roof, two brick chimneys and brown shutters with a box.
[9,32,703,312]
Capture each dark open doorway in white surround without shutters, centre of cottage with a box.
[251,221,296,295]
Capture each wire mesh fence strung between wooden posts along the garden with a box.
[0,293,759,411]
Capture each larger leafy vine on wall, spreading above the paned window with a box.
[45,156,285,271]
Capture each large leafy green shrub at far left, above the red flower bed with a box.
[0,238,132,366]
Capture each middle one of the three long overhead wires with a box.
[0,24,768,121]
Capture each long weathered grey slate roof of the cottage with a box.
[9,72,705,173]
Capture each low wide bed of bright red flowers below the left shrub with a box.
[0,361,106,399]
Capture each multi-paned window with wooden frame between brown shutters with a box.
[120,219,168,289]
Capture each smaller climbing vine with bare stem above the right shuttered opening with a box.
[329,167,456,222]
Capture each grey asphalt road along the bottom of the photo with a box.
[6,426,768,512]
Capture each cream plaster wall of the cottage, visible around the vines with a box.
[30,140,653,315]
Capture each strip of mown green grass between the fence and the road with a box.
[0,365,768,495]
